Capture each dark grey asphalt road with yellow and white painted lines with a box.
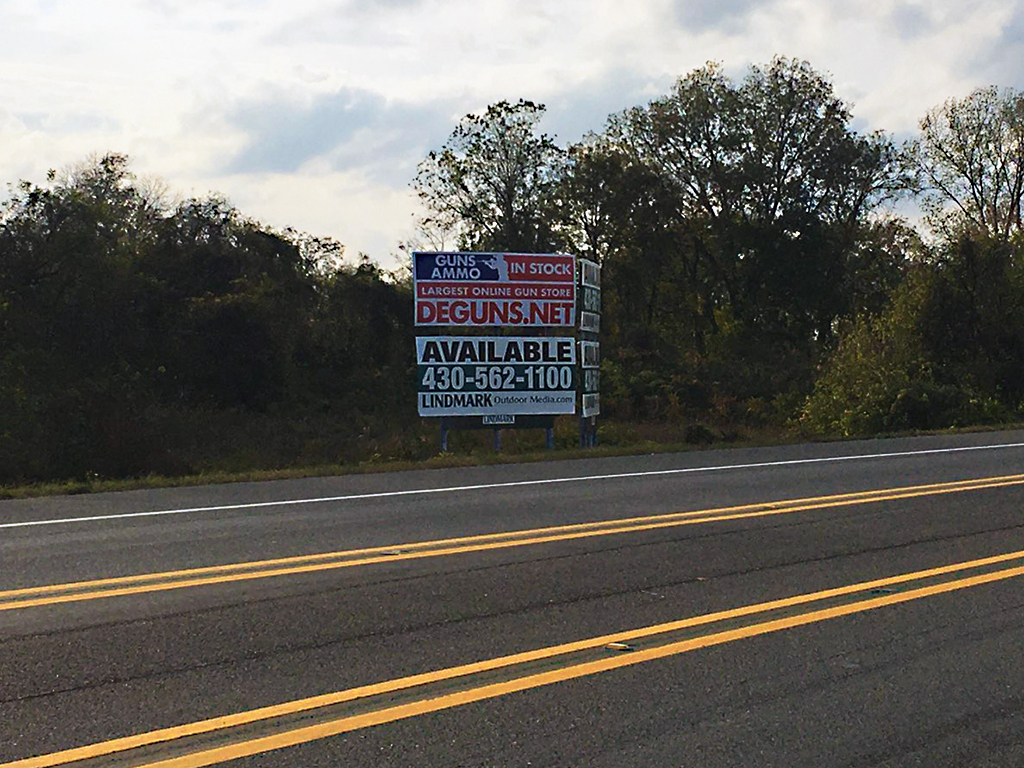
[0,432,1024,768]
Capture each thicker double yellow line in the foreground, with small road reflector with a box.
[8,550,1024,768]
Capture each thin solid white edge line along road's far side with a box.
[6,442,1024,528]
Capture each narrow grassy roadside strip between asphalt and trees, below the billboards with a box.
[0,420,1024,500]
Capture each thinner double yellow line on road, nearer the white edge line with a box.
[6,475,1024,611]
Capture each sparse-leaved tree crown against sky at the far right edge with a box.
[906,86,1024,241]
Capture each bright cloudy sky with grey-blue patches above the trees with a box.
[0,0,1024,265]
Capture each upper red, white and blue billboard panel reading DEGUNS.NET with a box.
[413,252,577,328]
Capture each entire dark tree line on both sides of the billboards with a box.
[0,58,1024,482]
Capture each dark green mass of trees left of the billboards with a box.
[0,155,413,482]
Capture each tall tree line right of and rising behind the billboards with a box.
[414,57,1024,435]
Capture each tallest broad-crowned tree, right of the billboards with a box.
[613,58,899,343]
